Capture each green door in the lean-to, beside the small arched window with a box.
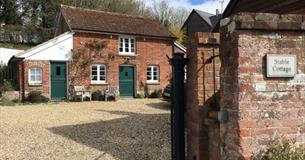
[51,62,67,100]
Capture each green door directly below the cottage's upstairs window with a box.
[120,66,134,97]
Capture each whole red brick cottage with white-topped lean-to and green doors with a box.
[11,6,177,99]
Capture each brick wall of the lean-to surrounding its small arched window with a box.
[18,61,50,97]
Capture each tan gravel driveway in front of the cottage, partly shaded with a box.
[0,99,170,160]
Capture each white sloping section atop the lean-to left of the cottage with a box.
[17,32,73,61]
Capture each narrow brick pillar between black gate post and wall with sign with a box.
[186,33,220,160]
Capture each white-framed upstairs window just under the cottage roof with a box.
[119,36,135,55]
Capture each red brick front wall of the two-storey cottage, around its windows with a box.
[70,33,173,92]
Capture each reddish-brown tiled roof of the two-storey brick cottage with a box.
[61,5,175,38]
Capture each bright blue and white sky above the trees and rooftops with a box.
[143,0,230,14]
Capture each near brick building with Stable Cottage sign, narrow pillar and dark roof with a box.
[187,0,305,160]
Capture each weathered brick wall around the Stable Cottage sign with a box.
[220,13,305,160]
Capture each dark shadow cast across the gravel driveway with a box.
[48,110,170,160]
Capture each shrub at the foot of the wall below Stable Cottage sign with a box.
[252,140,305,160]
